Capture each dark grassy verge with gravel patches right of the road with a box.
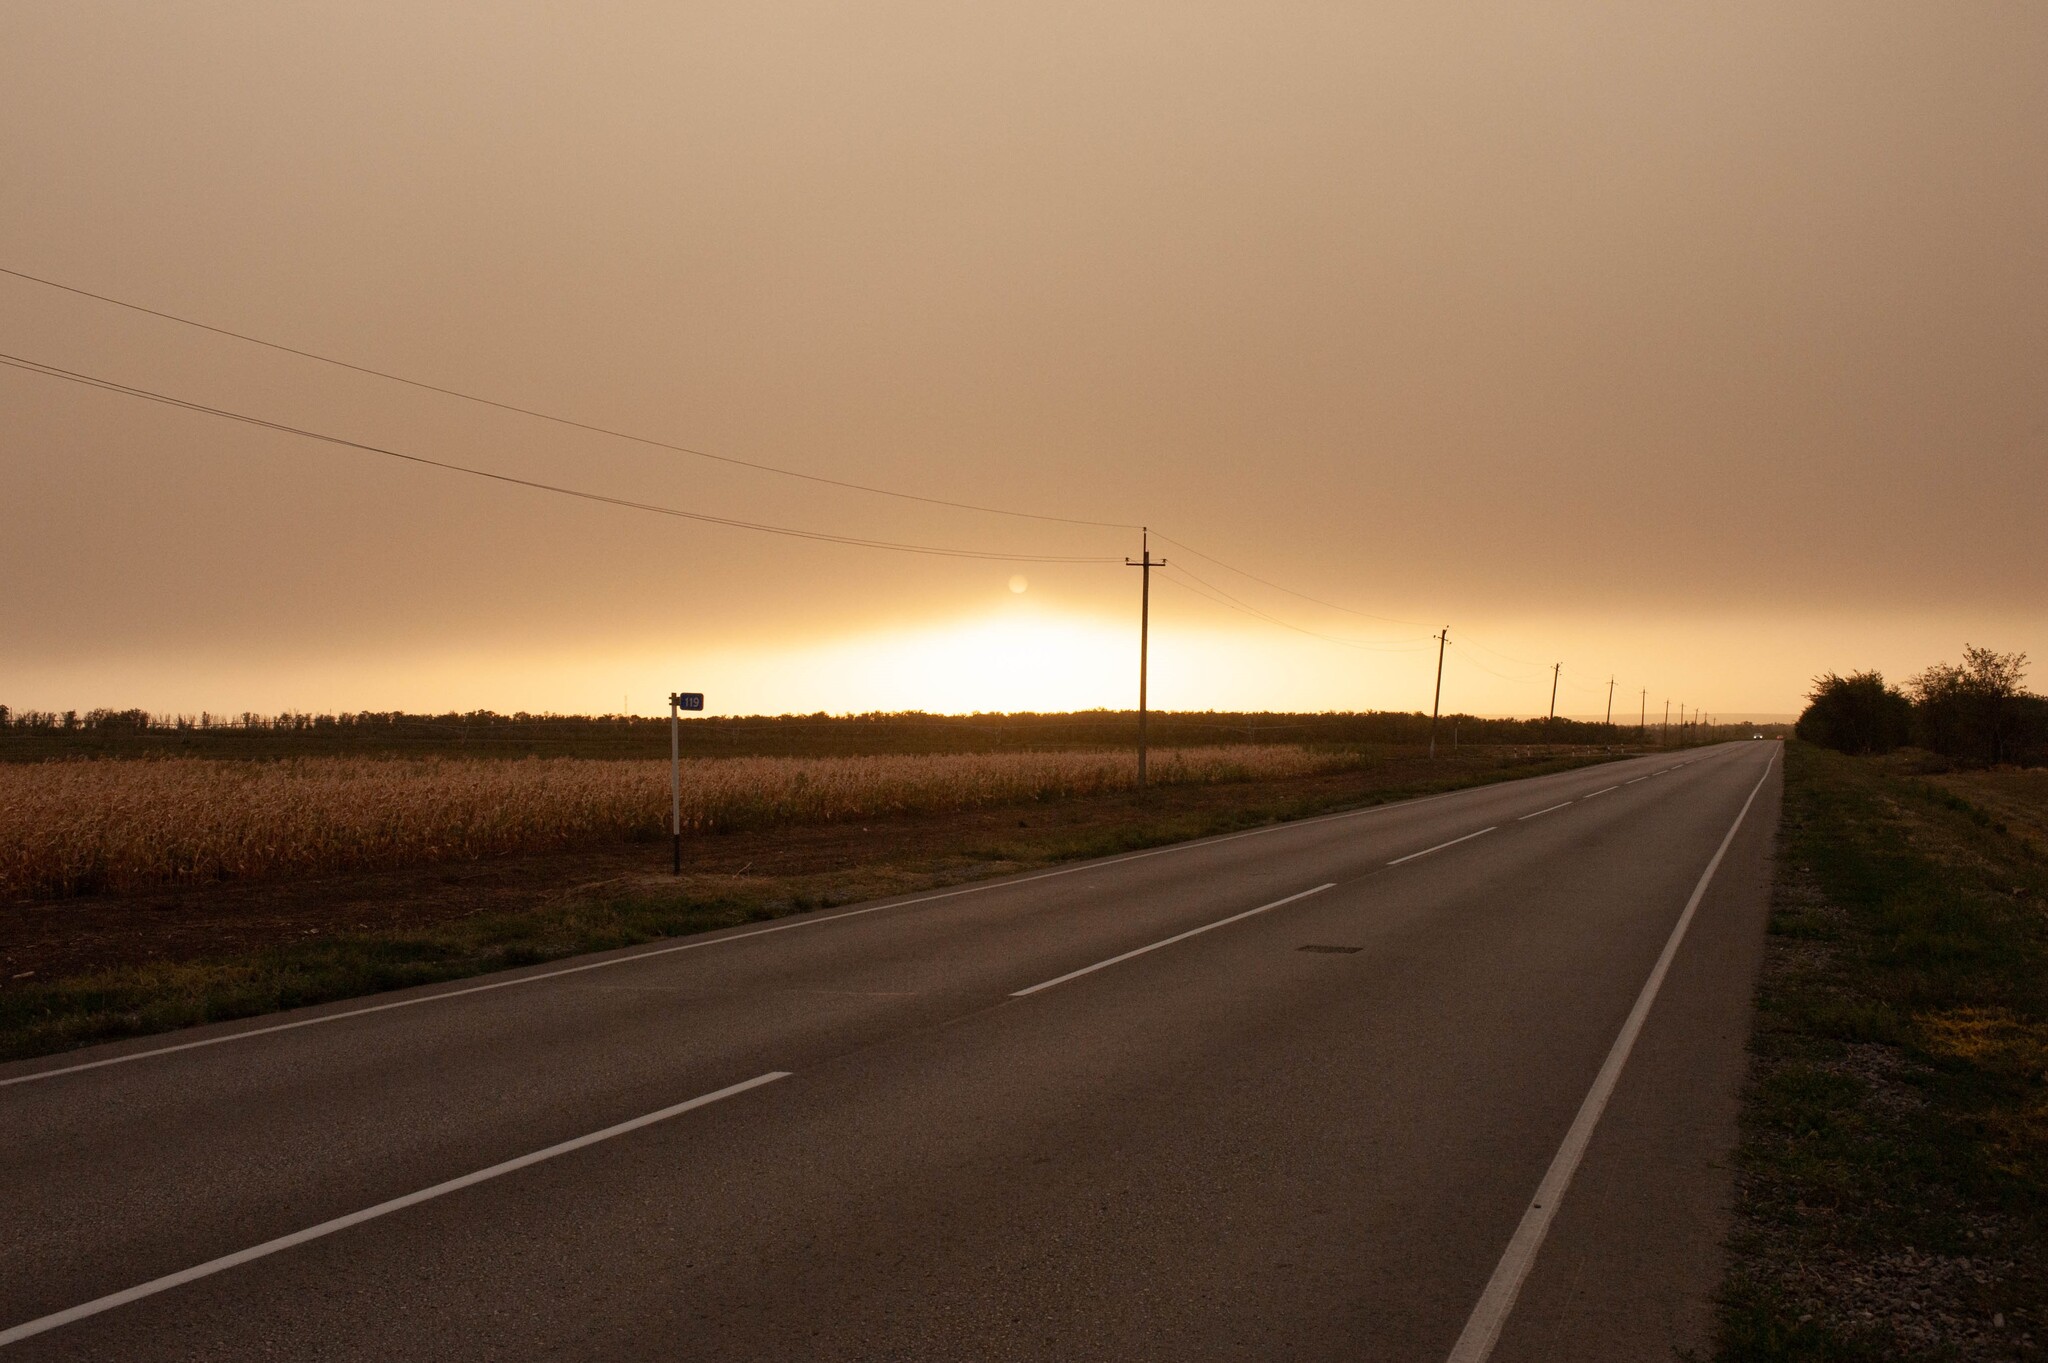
[1716,743,2048,1363]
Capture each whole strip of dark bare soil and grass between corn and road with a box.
[0,747,1612,1058]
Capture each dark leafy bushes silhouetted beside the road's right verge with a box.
[1798,647,2048,767]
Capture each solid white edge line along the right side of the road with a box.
[1448,749,1778,1363]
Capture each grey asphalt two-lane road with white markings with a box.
[0,743,1780,1363]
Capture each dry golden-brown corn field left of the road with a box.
[0,745,1358,898]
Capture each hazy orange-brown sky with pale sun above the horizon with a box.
[0,0,2048,716]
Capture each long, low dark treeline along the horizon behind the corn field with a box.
[0,706,1751,761]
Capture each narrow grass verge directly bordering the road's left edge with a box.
[0,753,1612,1060]
